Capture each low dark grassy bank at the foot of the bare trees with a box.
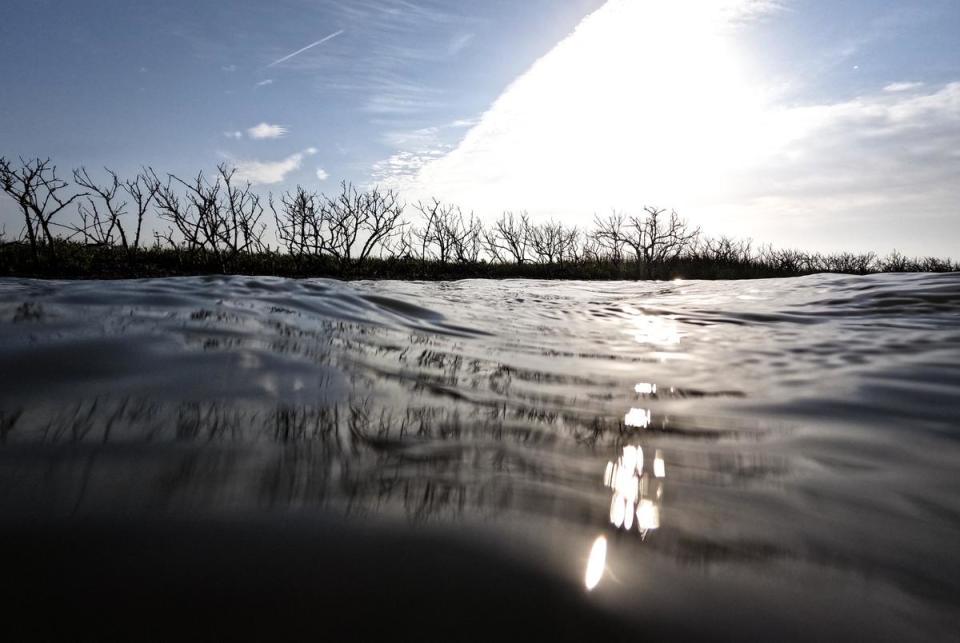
[0,241,960,281]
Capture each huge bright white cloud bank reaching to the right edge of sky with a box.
[375,0,960,254]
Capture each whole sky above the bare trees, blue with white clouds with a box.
[0,0,960,257]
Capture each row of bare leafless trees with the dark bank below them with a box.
[0,157,960,279]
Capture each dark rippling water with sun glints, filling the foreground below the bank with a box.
[0,274,960,640]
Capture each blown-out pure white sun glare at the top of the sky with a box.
[404,0,773,219]
